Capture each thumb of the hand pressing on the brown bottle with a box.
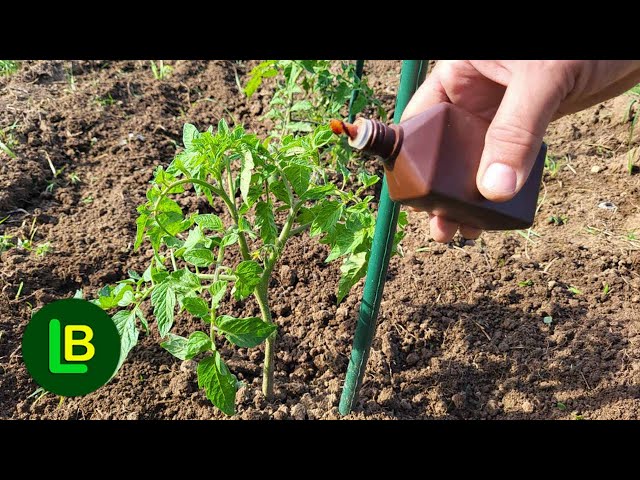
[476,71,562,202]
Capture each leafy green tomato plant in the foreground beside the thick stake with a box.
[90,63,406,415]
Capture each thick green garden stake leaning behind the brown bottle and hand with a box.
[339,60,428,415]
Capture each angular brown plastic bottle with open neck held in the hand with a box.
[349,103,547,230]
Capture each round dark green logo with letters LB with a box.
[22,298,120,397]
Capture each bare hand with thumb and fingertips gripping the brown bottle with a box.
[402,60,640,242]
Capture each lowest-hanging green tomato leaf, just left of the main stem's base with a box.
[198,351,237,415]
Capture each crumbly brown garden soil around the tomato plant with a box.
[0,61,640,419]
